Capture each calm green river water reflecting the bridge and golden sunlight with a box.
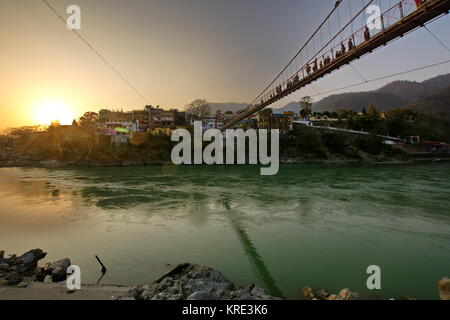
[0,163,450,299]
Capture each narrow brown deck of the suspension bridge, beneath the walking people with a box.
[223,0,450,130]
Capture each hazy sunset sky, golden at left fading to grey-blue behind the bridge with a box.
[0,0,450,130]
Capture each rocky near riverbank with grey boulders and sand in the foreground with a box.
[0,249,450,300]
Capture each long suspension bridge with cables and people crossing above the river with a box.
[222,0,450,130]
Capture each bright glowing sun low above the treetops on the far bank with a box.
[34,100,75,125]
